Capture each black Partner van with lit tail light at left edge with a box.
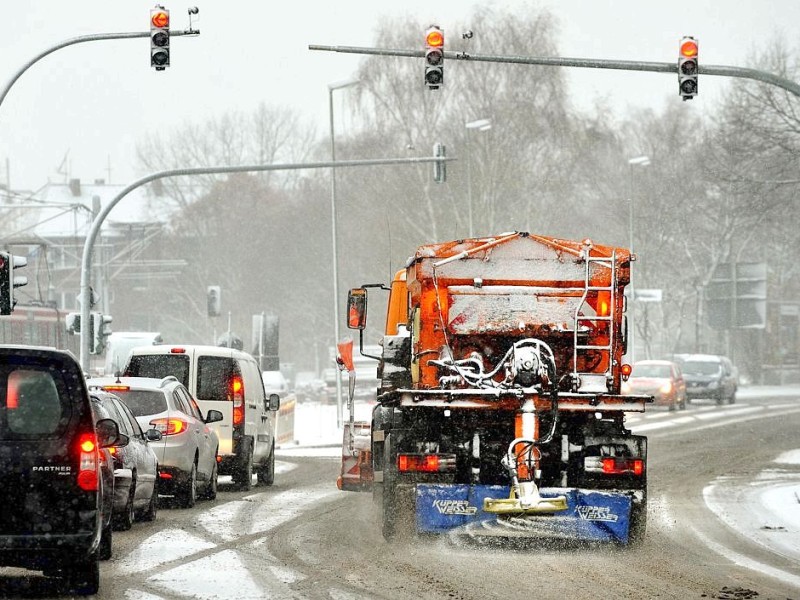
[0,345,128,594]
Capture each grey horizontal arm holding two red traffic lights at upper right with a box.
[308,44,800,97]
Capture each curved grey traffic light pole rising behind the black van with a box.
[79,156,456,373]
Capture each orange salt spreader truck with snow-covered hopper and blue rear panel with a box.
[338,232,652,544]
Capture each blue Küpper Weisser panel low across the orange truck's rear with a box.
[416,484,631,544]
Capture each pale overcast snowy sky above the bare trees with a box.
[0,0,800,189]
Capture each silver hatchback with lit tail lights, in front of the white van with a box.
[88,375,222,508]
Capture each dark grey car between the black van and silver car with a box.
[90,388,162,530]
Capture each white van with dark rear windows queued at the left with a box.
[124,344,280,490]
